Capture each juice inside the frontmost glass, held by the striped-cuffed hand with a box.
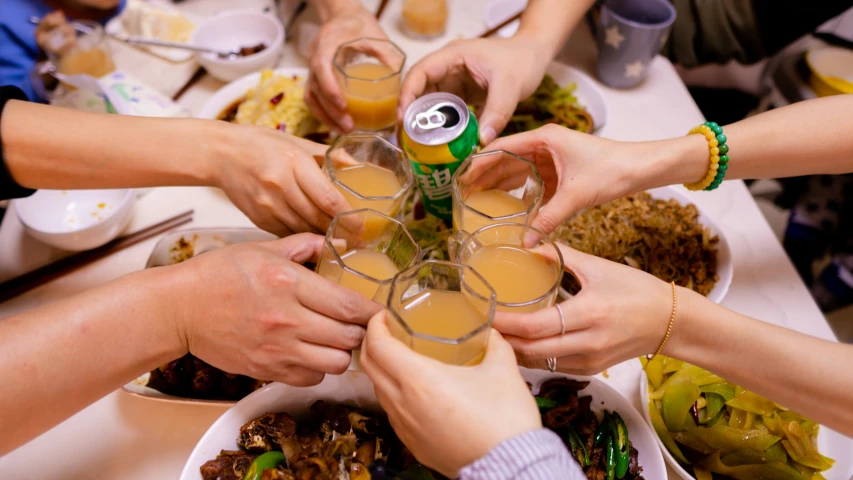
[392,290,488,365]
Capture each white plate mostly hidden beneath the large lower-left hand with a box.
[121,228,277,405]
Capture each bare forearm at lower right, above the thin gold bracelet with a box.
[664,288,853,435]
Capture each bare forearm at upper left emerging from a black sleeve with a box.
[0,101,230,189]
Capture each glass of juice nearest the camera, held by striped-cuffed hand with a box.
[388,260,495,365]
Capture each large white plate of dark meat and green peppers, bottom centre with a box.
[180,369,666,480]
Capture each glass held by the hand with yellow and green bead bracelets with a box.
[451,150,545,240]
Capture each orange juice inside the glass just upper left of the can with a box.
[343,63,400,130]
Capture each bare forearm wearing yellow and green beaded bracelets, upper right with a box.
[644,95,853,188]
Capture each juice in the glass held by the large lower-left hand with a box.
[318,249,397,298]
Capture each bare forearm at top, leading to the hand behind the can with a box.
[513,0,595,61]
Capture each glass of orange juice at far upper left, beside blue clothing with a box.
[48,20,115,82]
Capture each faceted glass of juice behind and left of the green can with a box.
[333,38,406,132]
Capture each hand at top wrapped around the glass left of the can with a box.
[305,3,387,133]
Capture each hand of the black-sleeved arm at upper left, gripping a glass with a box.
[212,125,350,236]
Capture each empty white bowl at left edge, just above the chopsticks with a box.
[13,189,136,251]
